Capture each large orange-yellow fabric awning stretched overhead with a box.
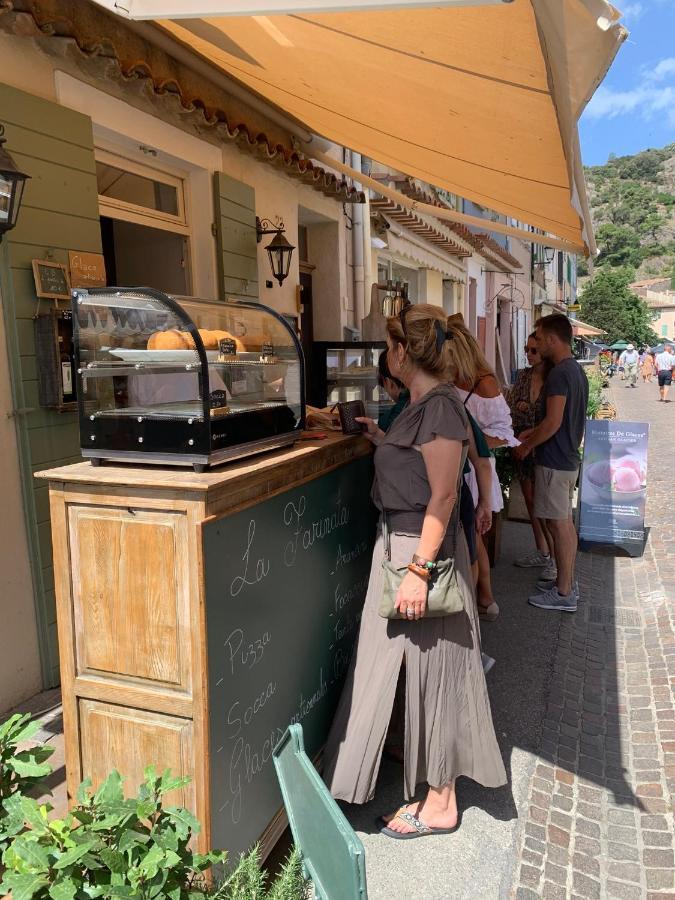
[87,0,626,252]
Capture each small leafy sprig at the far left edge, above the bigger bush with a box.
[0,713,54,859]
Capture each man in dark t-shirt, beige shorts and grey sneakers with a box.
[514,313,588,612]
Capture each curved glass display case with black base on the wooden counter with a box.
[73,288,305,471]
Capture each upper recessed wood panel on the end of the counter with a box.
[68,505,191,693]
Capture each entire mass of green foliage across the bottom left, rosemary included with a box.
[0,715,308,900]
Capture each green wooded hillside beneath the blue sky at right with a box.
[577,144,675,345]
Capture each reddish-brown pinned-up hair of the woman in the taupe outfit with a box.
[387,303,454,380]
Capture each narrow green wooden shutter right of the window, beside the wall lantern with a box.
[214,172,258,300]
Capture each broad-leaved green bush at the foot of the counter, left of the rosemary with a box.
[0,766,225,900]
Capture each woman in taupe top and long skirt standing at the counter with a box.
[324,304,506,840]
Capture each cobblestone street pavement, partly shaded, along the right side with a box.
[511,382,675,900]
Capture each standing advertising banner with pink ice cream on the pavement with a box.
[579,419,649,556]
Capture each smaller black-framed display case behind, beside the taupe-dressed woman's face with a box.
[312,341,392,419]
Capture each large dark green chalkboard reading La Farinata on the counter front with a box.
[203,457,375,856]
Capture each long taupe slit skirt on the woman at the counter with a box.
[324,530,506,803]
